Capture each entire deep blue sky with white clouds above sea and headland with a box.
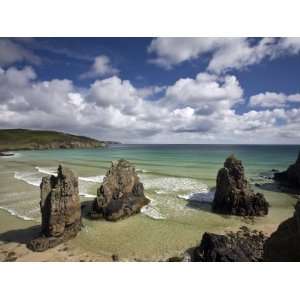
[0,38,300,144]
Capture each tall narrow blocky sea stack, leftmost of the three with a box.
[28,166,81,251]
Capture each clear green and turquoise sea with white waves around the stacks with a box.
[0,145,300,260]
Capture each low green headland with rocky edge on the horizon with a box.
[0,129,114,151]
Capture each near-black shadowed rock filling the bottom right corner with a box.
[264,201,300,261]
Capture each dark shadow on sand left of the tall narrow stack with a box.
[0,225,41,244]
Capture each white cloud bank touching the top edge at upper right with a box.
[148,37,300,74]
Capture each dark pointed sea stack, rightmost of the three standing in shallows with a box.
[213,155,269,216]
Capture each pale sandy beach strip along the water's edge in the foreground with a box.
[0,209,279,262]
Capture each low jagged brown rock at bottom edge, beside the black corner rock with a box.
[193,226,266,262]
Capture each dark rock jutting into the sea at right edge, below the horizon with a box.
[274,152,300,189]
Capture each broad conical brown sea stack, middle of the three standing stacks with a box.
[91,159,150,221]
